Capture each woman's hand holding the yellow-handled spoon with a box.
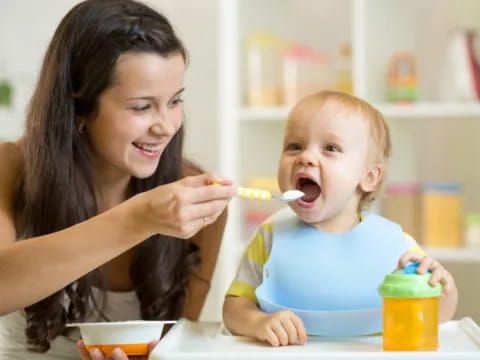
[136,174,235,239]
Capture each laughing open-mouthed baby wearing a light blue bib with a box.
[223,91,458,346]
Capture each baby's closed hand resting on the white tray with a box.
[254,310,307,346]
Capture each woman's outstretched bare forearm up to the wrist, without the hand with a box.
[0,191,151,314]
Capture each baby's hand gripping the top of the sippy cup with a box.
[397,251,455,294]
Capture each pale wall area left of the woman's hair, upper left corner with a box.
[0,0,77,139]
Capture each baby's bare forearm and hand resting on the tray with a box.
[223,296,307,346]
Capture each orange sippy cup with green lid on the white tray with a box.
[378,262,442,351]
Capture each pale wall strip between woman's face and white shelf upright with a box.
[145,0,218,171]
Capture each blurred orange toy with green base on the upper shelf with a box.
[387,53,418,103]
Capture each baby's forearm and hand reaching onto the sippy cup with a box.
[398,251,458,323]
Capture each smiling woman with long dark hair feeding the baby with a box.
[0,0,234,359]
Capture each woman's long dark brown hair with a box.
[18,0,198,352]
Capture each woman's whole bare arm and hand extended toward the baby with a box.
[0,144,234,314]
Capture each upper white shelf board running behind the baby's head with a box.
[239,102,480,122]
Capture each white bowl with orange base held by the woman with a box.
[67,320,176,356]
